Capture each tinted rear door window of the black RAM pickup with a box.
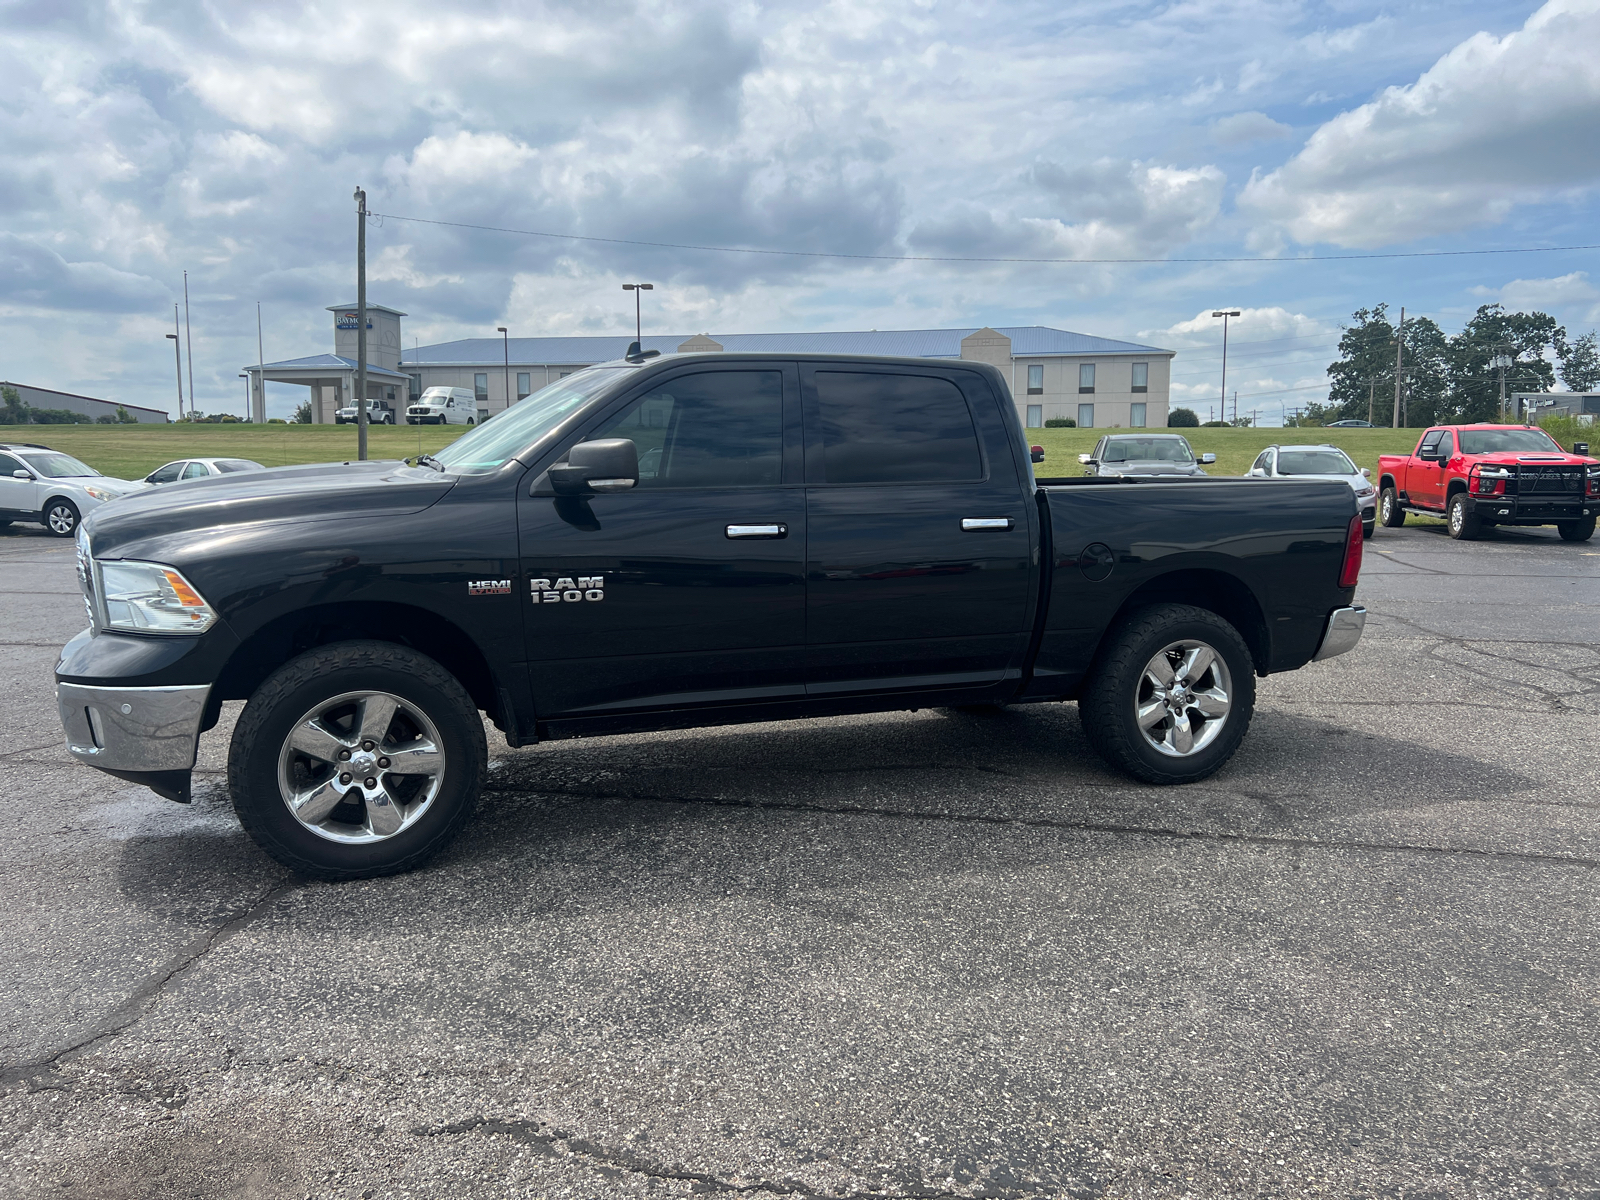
[816,371,984,483]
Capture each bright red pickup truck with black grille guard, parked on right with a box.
[1378,426,1600,542]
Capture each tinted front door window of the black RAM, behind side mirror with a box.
[589,371,784,488]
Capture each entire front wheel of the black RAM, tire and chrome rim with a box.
[227,642,486,880]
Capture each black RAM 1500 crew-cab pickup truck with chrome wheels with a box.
[56,354,1365,878]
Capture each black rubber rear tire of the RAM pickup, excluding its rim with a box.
[1078,603,1256,784]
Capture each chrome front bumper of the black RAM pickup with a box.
[56,683,211,803]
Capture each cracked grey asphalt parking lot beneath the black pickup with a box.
[0,525,1600,1200]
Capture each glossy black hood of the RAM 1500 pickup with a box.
[83,461,456,558]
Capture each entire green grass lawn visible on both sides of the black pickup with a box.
[0,424,1421,478]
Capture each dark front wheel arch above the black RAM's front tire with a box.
[205,600,499,728]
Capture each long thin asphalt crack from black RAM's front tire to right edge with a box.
[485,787,1600,869]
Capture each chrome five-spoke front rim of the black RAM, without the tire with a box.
[278,691,445,843]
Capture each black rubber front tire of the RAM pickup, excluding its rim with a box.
[227,642,488,880]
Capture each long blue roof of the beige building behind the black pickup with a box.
[406,325,1173,366]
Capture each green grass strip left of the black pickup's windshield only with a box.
[0,424,467,478]
